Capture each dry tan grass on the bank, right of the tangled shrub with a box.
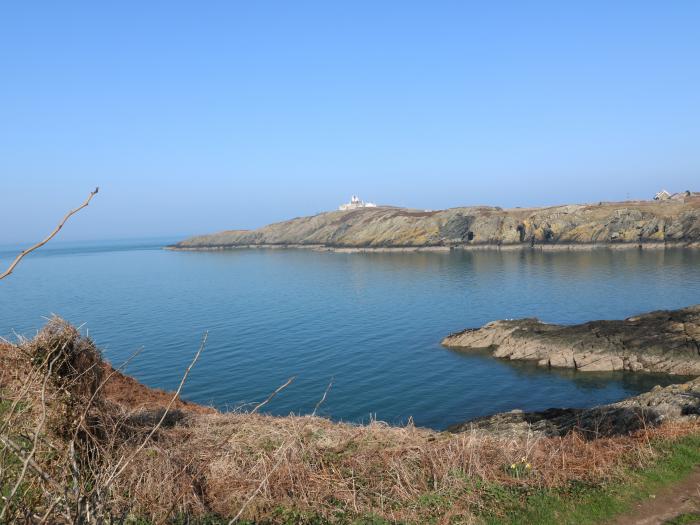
[113,414,698,522]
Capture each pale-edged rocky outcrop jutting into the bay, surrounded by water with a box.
[442,305,700,375]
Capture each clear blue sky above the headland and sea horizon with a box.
[0,0,700,243]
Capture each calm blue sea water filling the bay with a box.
[0,239,700,428]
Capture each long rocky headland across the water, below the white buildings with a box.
[174,197,700,249]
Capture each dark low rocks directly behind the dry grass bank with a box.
[447,379,700,439]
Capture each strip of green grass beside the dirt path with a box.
[480,435,700,525]
